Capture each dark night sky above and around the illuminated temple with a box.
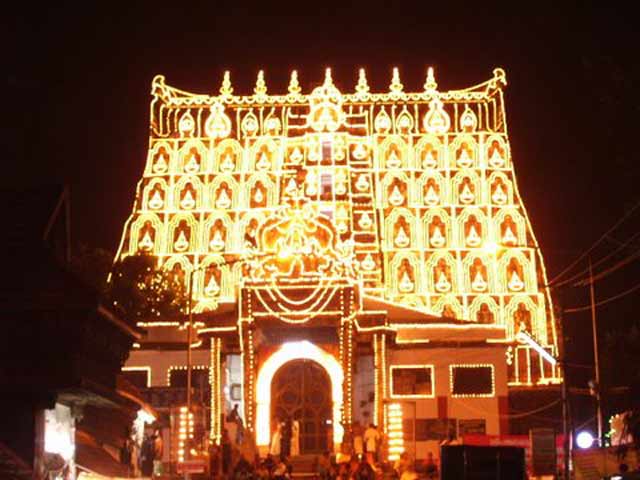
[5,1,640,424]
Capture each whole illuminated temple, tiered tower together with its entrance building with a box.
[117,65,562,461]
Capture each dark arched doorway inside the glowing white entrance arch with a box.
[271,359,333,454]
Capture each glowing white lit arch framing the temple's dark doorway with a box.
[256,341,344,449]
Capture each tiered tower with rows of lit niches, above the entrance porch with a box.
[118,69,558,382]
